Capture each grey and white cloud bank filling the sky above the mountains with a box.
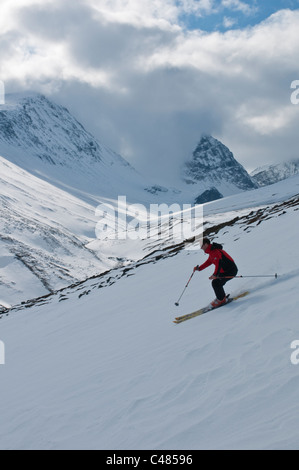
[0,0,299,179]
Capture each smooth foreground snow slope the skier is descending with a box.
[0,178,299,450]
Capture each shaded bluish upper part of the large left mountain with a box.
[0,93,152,204]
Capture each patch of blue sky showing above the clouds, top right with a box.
[180,0,299,32]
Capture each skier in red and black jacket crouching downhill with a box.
[193,238,238,308]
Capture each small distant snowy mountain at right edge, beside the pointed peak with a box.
[251,159,299,186]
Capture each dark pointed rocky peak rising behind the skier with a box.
[184,135,257,204]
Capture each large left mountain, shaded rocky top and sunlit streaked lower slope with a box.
[0,93,185,303]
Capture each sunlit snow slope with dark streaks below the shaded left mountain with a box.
[0,152,106,303]
